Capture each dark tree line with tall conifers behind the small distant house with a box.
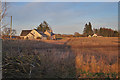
[74,22,120,37]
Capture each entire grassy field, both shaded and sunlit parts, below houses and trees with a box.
[2,37,119,78]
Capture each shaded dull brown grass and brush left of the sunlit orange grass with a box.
[3,40,75,78]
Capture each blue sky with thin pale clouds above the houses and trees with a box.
[8,2,118,35]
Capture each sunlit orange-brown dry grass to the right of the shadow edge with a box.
[68,37,119,78]
